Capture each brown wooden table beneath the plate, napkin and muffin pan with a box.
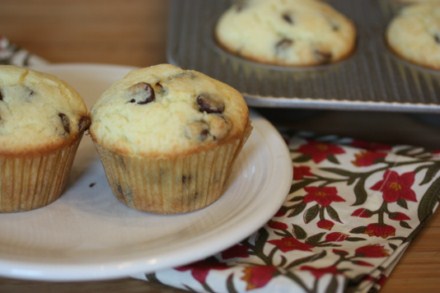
[0,0,440,293]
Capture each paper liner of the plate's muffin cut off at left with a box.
[0,135,82,212]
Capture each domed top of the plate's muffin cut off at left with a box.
[0,65,90,155]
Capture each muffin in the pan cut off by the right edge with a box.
[386,1,440,70]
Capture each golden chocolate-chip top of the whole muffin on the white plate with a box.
[90,64,249,157]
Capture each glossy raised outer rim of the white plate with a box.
[0,63,293,281]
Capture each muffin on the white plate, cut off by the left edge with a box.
[0,65,90,212]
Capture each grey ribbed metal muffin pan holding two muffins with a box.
[167,0,440,113]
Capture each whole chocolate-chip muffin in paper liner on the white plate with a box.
[90,64,251,214]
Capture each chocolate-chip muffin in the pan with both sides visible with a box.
[215,0,356,66]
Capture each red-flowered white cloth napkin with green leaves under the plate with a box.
[5,36,440,292]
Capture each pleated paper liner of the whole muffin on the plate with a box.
[95,130,250,214]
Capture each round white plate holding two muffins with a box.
[0,64,292,281]
